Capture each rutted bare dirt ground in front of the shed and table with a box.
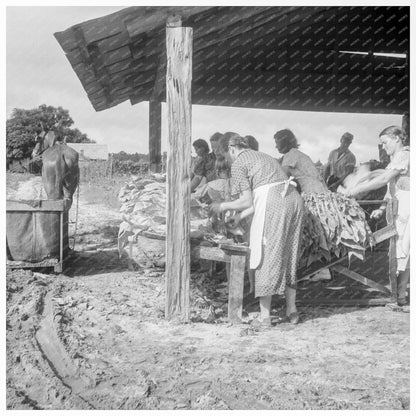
[6,174,410,410]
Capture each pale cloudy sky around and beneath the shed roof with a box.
[6,6,401,162]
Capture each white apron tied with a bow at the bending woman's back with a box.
[250,176,296,269]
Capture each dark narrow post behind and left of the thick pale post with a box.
[149,101,162,172]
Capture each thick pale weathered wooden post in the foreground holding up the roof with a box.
[165,24,192,322]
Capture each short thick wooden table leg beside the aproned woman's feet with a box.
[228,255,246,323]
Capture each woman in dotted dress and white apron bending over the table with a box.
[211,133,303,326]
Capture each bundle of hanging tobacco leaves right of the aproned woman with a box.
[301,192,374,266]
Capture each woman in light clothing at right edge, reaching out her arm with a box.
[347,126,410,306]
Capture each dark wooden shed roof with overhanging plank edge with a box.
[55,6,410,114]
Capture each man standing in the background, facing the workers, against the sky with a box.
[324,132,356,192]
